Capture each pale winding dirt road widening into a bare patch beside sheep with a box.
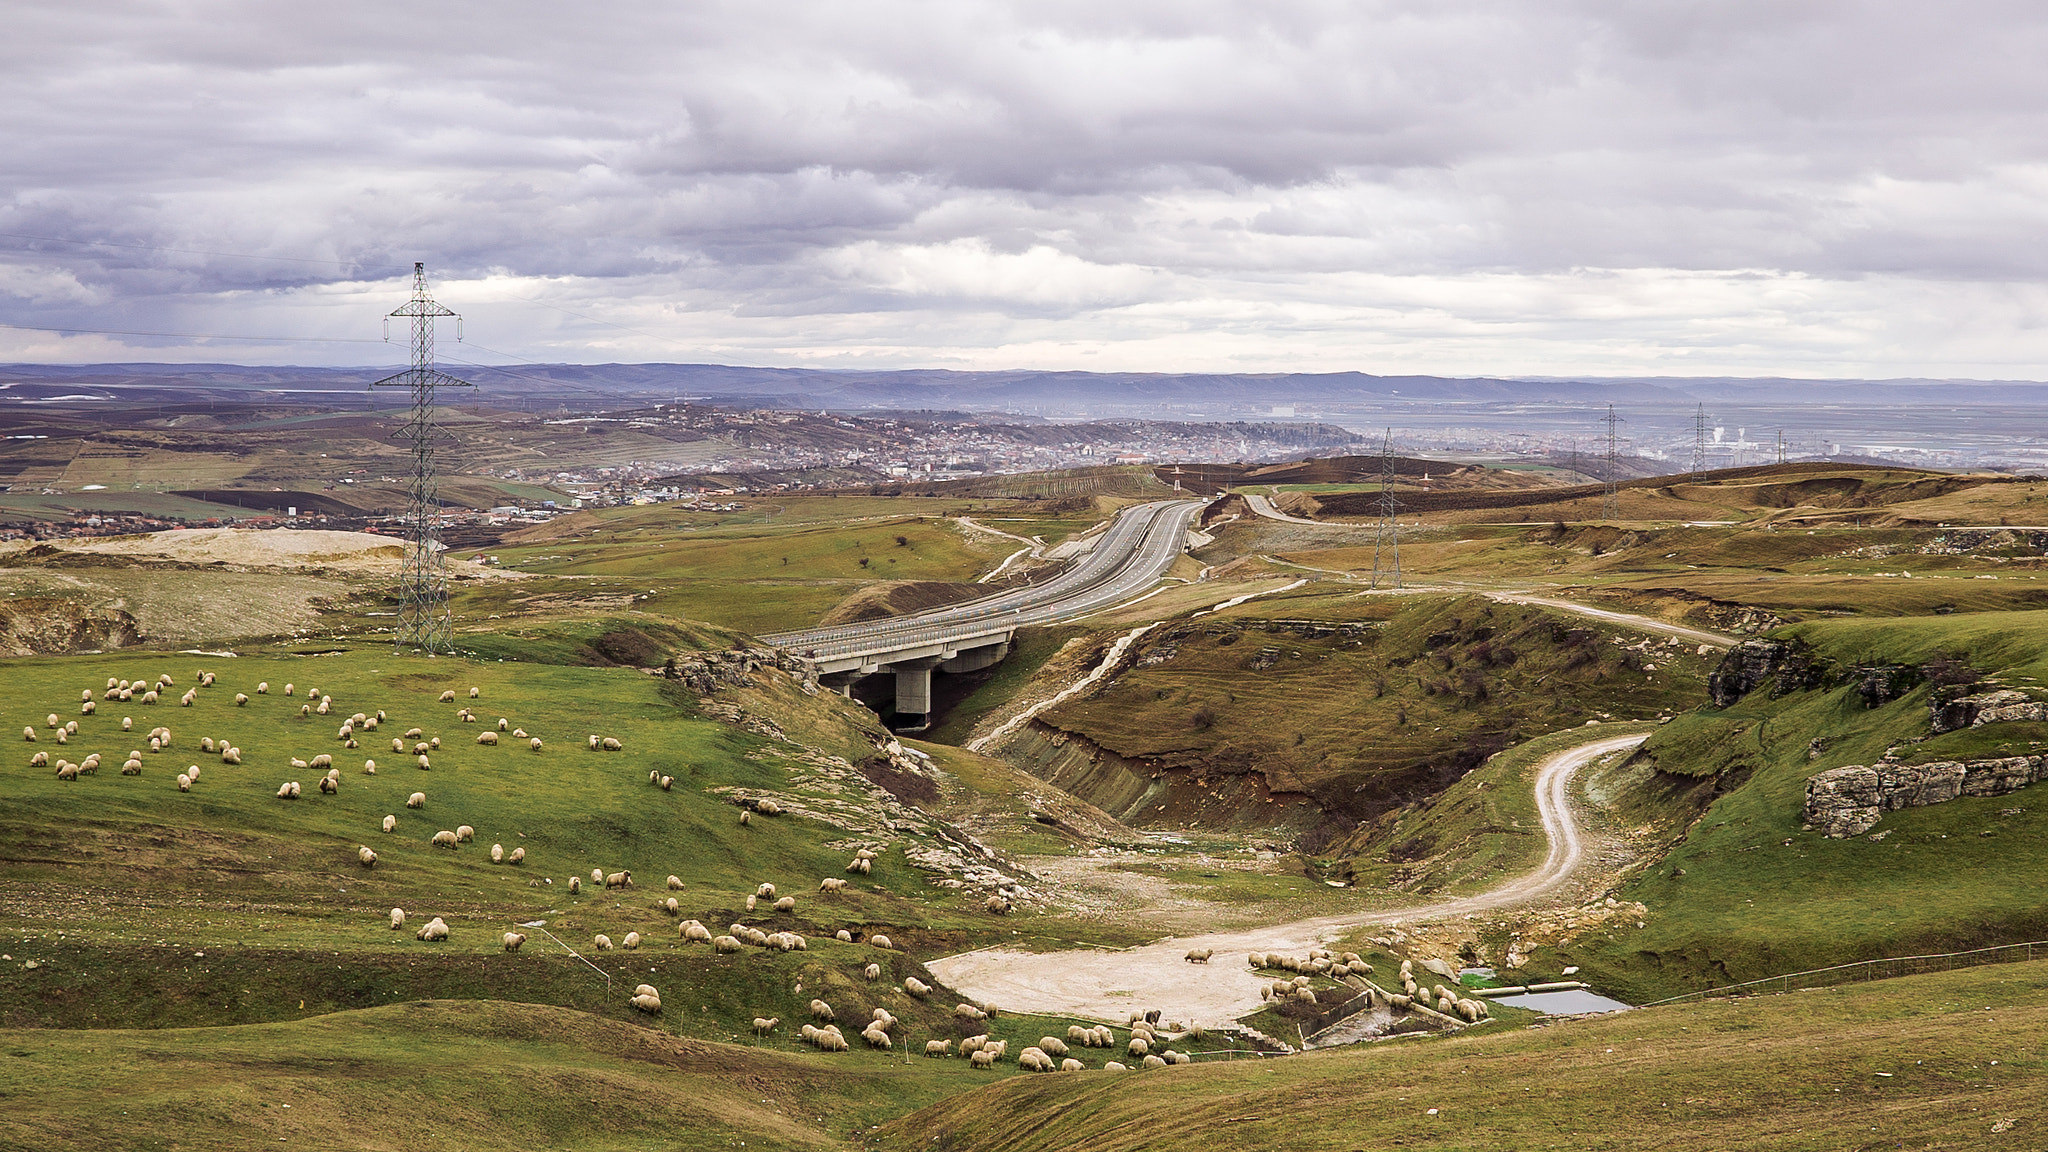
[926,734,1645,1025]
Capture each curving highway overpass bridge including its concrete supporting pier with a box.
[762,500,1202,715]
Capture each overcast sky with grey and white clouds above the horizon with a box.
[0,0,2048,379]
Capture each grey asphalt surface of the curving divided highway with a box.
[762,500,1202,660]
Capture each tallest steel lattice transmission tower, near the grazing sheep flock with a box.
[371,262,475,652]
